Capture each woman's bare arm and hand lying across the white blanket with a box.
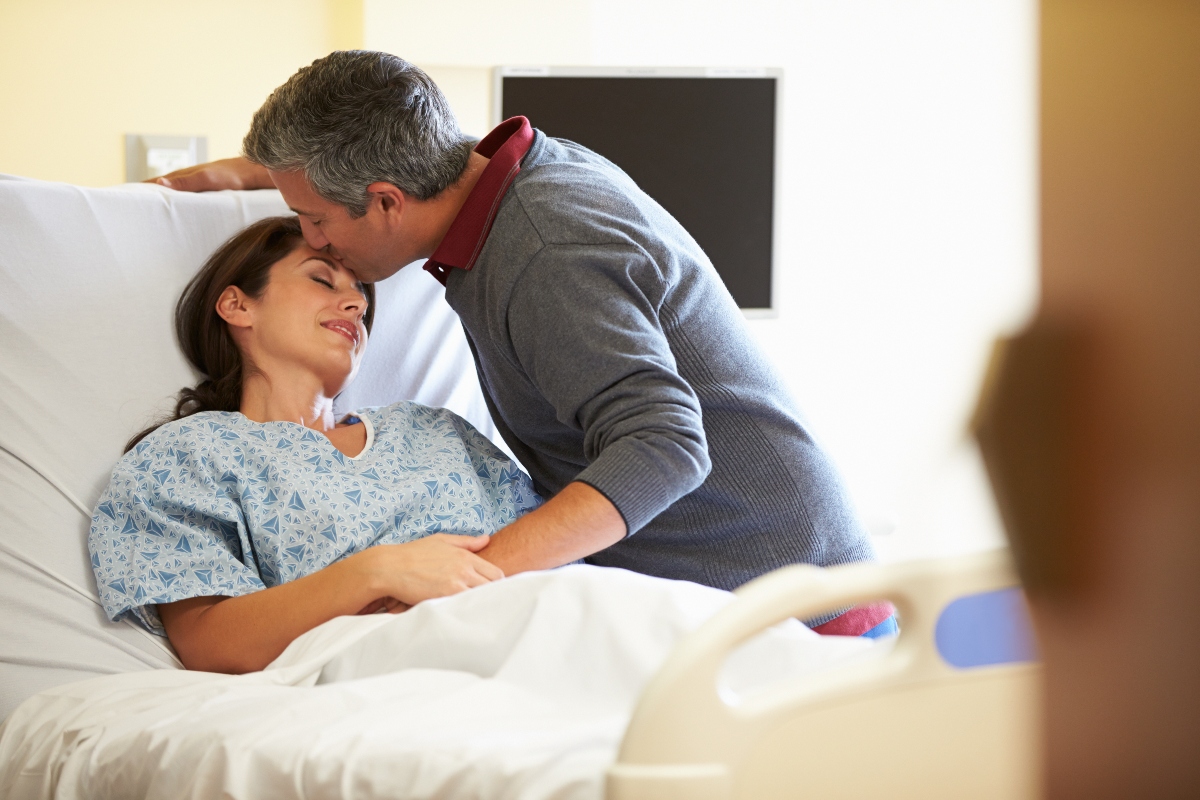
[158,534,504,673]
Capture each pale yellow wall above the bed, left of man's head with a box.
[0,0,362,186]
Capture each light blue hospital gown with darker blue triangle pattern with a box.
[88,402,541,634]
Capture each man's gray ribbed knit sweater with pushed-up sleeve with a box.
[446,132,872,589]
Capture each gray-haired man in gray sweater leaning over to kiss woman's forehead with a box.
[160,50,895,636]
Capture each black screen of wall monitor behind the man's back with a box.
[500,76,775,308]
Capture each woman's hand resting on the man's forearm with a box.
[347,534,504,610]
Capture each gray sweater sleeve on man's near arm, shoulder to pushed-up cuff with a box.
[505,245,712,534]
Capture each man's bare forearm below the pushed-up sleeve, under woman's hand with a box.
[479,481,626,575]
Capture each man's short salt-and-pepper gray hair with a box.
[242,50,472,217]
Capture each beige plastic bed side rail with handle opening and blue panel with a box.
[607,549,1039,800]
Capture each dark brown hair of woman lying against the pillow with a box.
[125,217,374,452]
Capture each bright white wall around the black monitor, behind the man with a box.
[364,0,1037,559]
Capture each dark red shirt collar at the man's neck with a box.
[425,116,533,285]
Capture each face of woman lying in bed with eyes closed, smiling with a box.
[230,245,367,397]
